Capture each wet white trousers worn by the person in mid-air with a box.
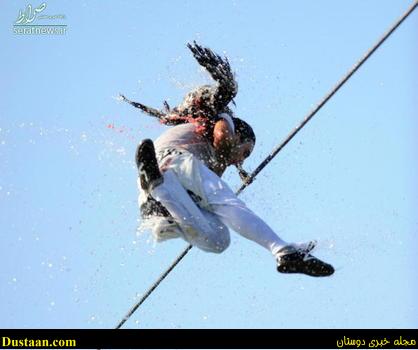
[139,152,288,254]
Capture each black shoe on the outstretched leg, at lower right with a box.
[277,242,334,277]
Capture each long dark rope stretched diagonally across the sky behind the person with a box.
[115,0,418,329]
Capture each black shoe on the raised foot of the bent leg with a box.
[135,139,163,192]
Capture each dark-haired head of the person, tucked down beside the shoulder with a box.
[231,117,256,164]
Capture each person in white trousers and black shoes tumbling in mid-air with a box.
[131,42,334,277]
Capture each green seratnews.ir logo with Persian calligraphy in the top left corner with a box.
[13,2,67,35]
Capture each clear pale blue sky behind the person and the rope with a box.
[0,0,418,328]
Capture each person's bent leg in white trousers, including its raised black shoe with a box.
[135,139,229,253]
